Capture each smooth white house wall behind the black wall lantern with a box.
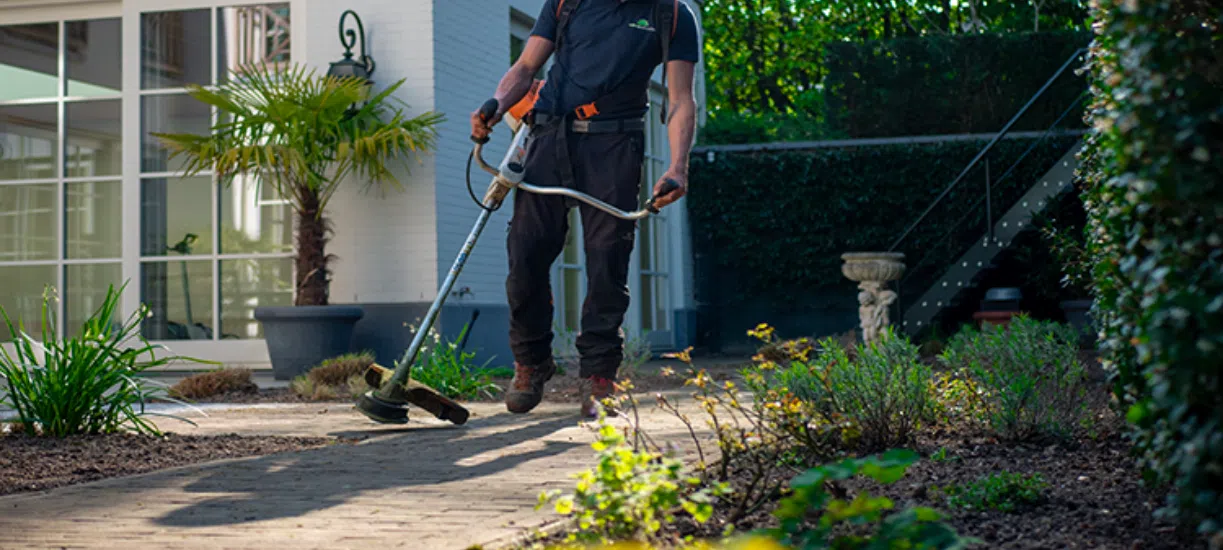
[305,0,442,303]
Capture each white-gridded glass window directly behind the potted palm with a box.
[139,4,294,340]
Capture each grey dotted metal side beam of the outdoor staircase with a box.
[903,142,1082,335]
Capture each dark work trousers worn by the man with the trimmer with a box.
[505,117,645,379]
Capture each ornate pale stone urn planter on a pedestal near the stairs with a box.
[841,252,905,343]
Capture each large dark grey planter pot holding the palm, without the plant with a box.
[254,306,366,380]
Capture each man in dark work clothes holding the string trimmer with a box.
[471,0,700,418]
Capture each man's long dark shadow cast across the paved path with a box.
[153,412,587,527]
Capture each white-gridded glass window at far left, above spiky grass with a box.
[0,17,124,340]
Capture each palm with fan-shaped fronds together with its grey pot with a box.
[154,64,443,380]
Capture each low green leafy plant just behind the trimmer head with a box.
[408,317,501,400]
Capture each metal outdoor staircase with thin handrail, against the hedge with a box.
[888,48,1087,335]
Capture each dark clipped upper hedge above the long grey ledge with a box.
[824,31,1091,138]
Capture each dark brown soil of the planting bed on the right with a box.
[530,374,1207,550]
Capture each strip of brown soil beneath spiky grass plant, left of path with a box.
[0,433,338,495]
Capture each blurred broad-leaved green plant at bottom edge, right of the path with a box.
[762,449,978,550]
